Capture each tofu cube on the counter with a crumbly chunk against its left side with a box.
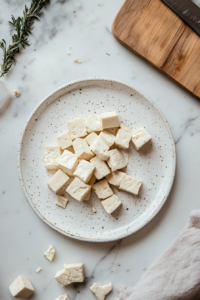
[64,263,85,282]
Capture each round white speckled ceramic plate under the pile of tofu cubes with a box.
[18,79,176,242]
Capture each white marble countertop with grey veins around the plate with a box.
[0,0,200,300]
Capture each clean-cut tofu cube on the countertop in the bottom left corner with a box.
[9,275,34,299]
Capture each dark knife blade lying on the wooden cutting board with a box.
[161,0,200,36]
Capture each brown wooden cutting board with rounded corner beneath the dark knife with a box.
[112,0,200,97]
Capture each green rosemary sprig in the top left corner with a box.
[0,0,50,77]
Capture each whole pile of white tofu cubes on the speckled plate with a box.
[44,112,151,214]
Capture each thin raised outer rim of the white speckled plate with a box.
[17,77,176,242]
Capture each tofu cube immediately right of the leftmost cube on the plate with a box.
[58,150,78,176]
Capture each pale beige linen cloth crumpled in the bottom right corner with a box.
[115,210,200,300]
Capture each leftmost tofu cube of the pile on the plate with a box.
[44,146,62,170]
